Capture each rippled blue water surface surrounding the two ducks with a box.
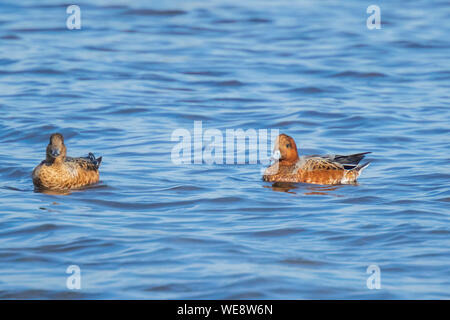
[0,0,450,299]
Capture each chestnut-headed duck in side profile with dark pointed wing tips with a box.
[263,134,370,184]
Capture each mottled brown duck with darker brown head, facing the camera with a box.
[32,133,102,190]
